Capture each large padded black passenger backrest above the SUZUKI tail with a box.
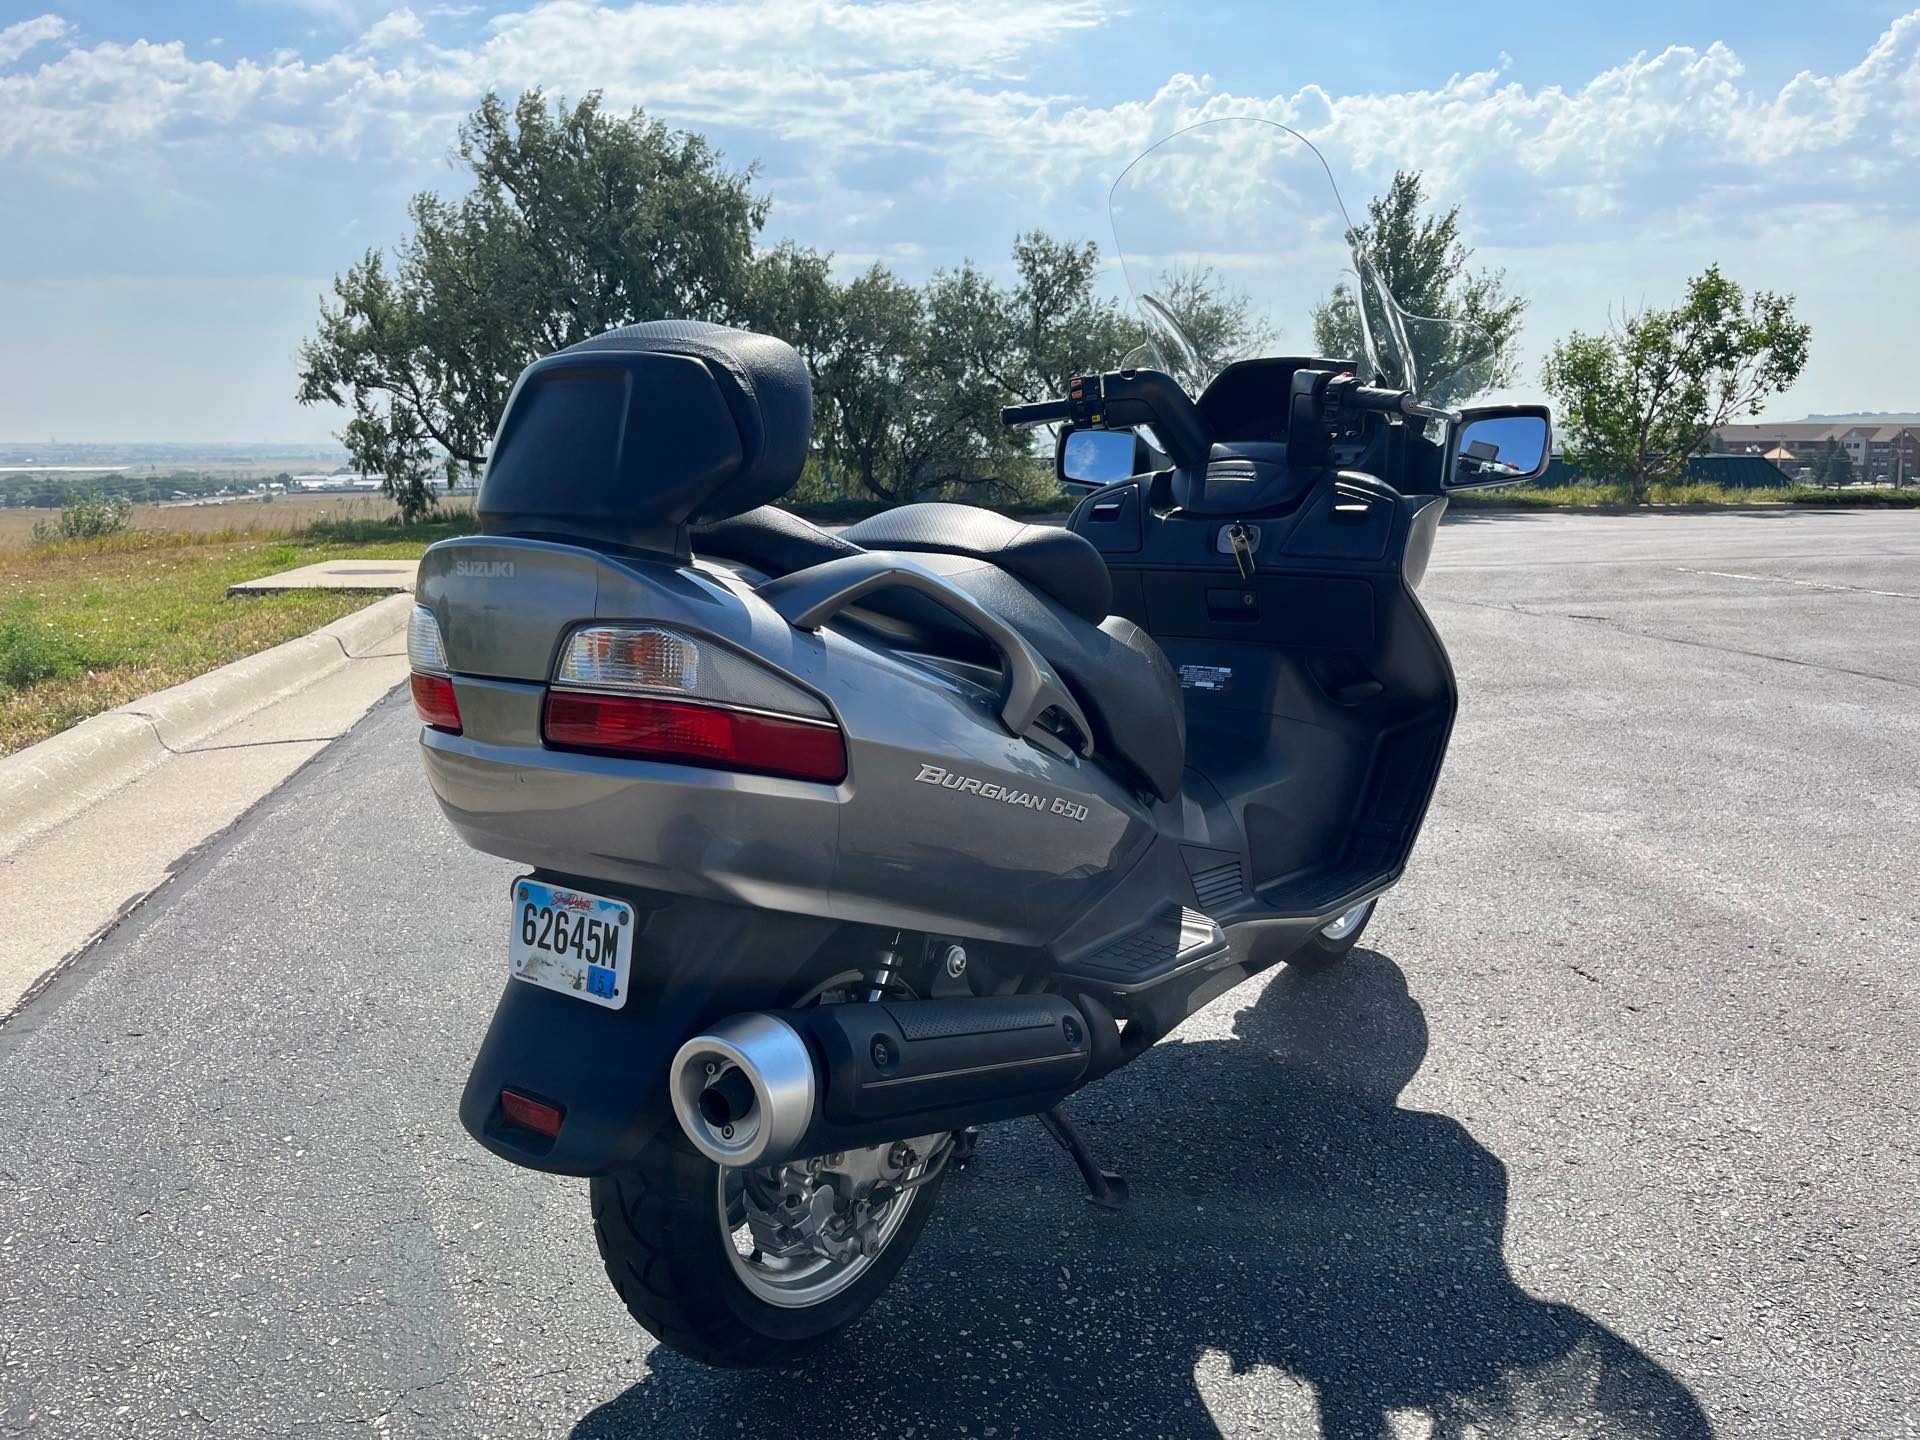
[478,321,812,549]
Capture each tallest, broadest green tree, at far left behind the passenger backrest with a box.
[298,90,764,518]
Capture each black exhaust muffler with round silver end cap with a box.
[668,995,1092,1165]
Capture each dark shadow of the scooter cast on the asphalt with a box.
[574,950,1713,1440]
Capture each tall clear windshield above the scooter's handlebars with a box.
[1108,117,1498,405]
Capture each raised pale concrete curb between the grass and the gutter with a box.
[0,595,413,854]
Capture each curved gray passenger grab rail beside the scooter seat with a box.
[756,551,1092,755]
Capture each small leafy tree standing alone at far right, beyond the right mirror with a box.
[1542,265,1812,503]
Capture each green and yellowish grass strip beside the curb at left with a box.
[0,516,472,755]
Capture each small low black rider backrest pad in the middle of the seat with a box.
[847,503,1114,624]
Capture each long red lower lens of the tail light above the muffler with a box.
[545,691,847,783]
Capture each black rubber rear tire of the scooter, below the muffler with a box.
[591,1127,947,1367]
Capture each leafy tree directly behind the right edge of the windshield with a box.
[1313,171,1526,405]
